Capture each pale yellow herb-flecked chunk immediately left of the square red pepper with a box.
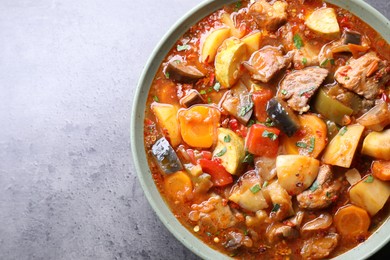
[213,128,245,174]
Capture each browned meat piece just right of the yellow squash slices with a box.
[244,46,292,82]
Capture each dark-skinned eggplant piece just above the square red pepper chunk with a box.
[266,97,300,137]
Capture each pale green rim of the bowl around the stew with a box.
[130,0,390,259]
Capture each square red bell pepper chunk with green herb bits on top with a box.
[245,124,280,157]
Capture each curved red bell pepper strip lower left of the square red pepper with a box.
[198,159,233,186]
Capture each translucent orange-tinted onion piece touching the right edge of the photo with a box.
[356,101,390,132]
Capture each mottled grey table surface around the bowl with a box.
[0,0,390,259]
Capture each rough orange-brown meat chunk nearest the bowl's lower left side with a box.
[189,195,237,232]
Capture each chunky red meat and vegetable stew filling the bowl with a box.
[144,0,390,259]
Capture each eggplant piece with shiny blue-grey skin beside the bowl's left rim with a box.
[152,137,183,174]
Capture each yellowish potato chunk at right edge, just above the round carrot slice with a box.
[349,175,390,216]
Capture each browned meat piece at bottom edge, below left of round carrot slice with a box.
[301,233,339,259]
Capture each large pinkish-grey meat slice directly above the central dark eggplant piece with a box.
[278,67,328,113]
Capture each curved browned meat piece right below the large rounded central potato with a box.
[297,164,341,209]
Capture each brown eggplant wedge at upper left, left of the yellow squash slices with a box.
[165,60,205,83]
